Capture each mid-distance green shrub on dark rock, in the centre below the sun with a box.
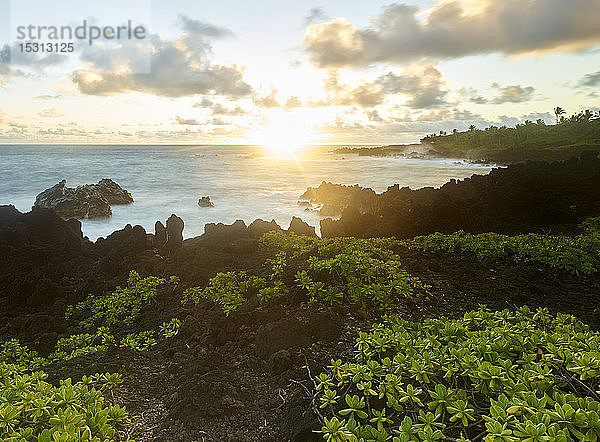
[183,232,430,315]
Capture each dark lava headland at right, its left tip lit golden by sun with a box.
[300,151,600,238]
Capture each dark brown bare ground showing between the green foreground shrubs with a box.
[29,243,600,441]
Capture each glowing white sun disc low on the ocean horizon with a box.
[256,115,315,157]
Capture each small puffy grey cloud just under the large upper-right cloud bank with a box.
[377,65,448,109]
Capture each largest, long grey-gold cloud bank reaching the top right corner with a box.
[304,0,600,67]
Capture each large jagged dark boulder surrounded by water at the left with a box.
[33,178,133,219]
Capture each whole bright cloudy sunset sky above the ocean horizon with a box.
[0,0,600,145]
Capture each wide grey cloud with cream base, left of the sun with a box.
[72,17,252,97]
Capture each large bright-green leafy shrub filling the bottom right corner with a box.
[316,307,600,442]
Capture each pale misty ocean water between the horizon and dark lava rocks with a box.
[0,145,490,240]
